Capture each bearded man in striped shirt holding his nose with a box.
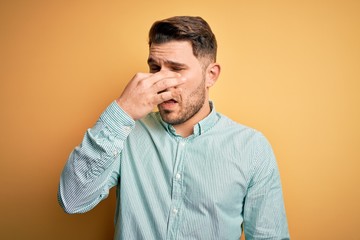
[59,17,289,240]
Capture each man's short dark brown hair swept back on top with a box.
[149,16,217,62]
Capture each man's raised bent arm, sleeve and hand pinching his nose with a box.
[58,71,186,213]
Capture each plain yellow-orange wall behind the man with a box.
[0,0,360,240]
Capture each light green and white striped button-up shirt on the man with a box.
[58,102,289,240]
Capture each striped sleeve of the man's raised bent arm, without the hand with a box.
[58,101,135,213]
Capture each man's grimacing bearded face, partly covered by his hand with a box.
[148,41,208,125]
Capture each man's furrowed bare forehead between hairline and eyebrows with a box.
[149,41,196,61]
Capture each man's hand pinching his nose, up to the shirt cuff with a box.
[116,71,185,120]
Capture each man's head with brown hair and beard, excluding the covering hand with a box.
[148,16,220,134]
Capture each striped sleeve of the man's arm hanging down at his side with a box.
[244,133,290,240]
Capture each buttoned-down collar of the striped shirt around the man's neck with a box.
[157,101,219,137]
